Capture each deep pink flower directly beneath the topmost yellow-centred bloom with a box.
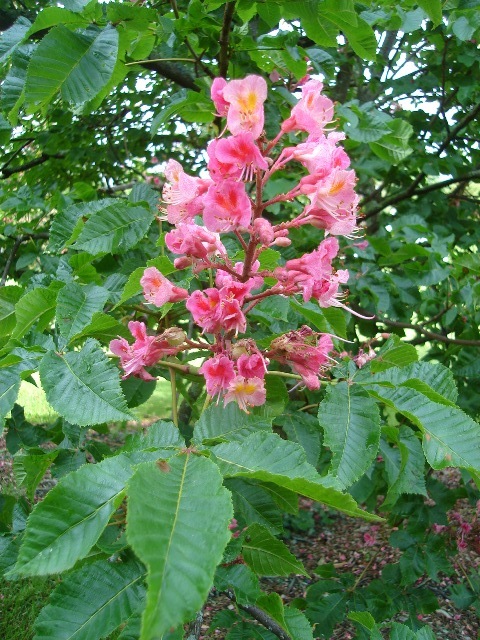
[209,131,268,181]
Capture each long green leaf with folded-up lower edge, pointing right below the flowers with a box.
[211,432,379,520]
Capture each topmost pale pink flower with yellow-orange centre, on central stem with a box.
[222,75,267,140]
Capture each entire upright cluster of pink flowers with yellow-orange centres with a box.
[111,75,358,411]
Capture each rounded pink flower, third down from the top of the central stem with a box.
[203,179,252,232]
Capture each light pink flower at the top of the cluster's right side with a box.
[282,80,333,136]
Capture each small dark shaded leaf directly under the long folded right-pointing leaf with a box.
[225,478,283,534]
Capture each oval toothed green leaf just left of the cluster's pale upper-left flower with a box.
[73,200,153,256]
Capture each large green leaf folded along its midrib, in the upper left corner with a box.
[25,25,118,113]
